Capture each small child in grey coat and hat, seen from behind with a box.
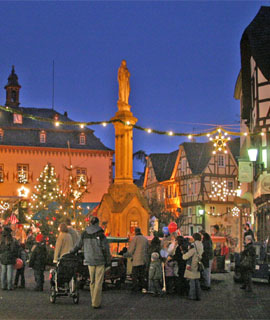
[148,252,162,297]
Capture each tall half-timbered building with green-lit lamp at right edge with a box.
[234,7,270,240]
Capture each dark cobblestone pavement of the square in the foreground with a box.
[0,269,270,320]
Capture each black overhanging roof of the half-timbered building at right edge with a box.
[241,6,270,120]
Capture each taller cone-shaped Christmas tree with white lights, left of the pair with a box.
[30,163,63,244]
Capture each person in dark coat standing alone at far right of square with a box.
[240,235,256,292]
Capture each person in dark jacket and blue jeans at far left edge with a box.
[0,228,19,290]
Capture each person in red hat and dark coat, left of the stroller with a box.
[29,233,47,291]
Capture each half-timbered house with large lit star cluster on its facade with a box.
[175,139,239,236]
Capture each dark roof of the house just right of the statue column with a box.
[149,150,178,181]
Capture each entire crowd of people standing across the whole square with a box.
[0,217,256,308]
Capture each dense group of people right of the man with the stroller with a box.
[125,228,213,300]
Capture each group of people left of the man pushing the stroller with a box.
[0,219,79,291]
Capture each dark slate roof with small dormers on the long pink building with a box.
[0,108,110,150]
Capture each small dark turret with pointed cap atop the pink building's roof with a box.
[5,66,21,108]
